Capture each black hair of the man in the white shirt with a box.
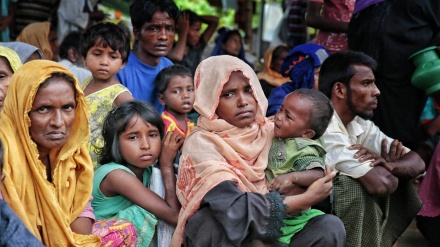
[318,51,377,99]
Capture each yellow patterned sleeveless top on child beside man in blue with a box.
[82,78,130,167]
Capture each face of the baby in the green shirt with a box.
[274,94,315,139]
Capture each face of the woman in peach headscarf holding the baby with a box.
[216,71,258,128]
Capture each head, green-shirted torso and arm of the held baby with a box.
[266,89,333,194]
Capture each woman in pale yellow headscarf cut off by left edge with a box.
[0,46,21,111]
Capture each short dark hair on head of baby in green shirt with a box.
[291,88,334,140]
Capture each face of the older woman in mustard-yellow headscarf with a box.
[29,77,76,155]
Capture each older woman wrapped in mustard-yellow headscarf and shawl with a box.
[0,60,136,246]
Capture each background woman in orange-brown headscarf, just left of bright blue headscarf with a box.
[257,45,290,98]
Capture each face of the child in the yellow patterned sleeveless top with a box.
[84,40,125,81]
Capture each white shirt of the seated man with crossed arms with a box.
[322,112,410,178]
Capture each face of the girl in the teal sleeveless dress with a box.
[119,115,162,171]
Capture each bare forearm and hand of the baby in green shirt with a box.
[269,168,324,194]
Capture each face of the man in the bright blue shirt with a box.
[133,11,176,61]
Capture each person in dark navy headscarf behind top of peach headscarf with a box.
[211,27,254,68]
